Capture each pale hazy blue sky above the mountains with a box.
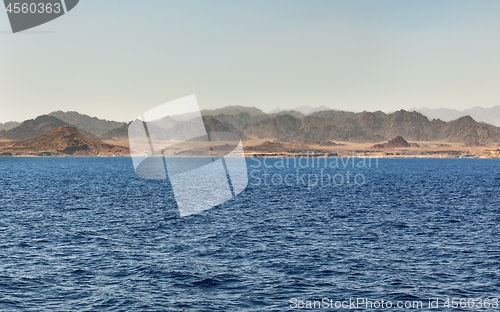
[0,0,500,122]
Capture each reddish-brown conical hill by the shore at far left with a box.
[0,126,130,156]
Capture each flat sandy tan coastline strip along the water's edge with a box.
[0,138,500,159]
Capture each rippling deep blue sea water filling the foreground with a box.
[0,157,500,311]
